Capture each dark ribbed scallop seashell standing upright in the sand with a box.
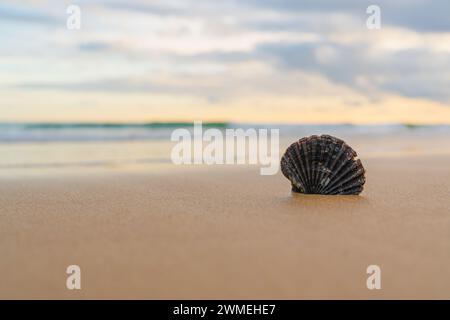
[281,135,366,194]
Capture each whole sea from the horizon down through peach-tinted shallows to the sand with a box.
[0,122,450,174]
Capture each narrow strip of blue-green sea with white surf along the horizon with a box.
[0,122,450,143]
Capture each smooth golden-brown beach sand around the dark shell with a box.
[0,156,450,299]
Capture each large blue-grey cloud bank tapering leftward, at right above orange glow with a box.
[256,39,450,102]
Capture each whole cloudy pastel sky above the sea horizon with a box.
[0,0,450,124]
